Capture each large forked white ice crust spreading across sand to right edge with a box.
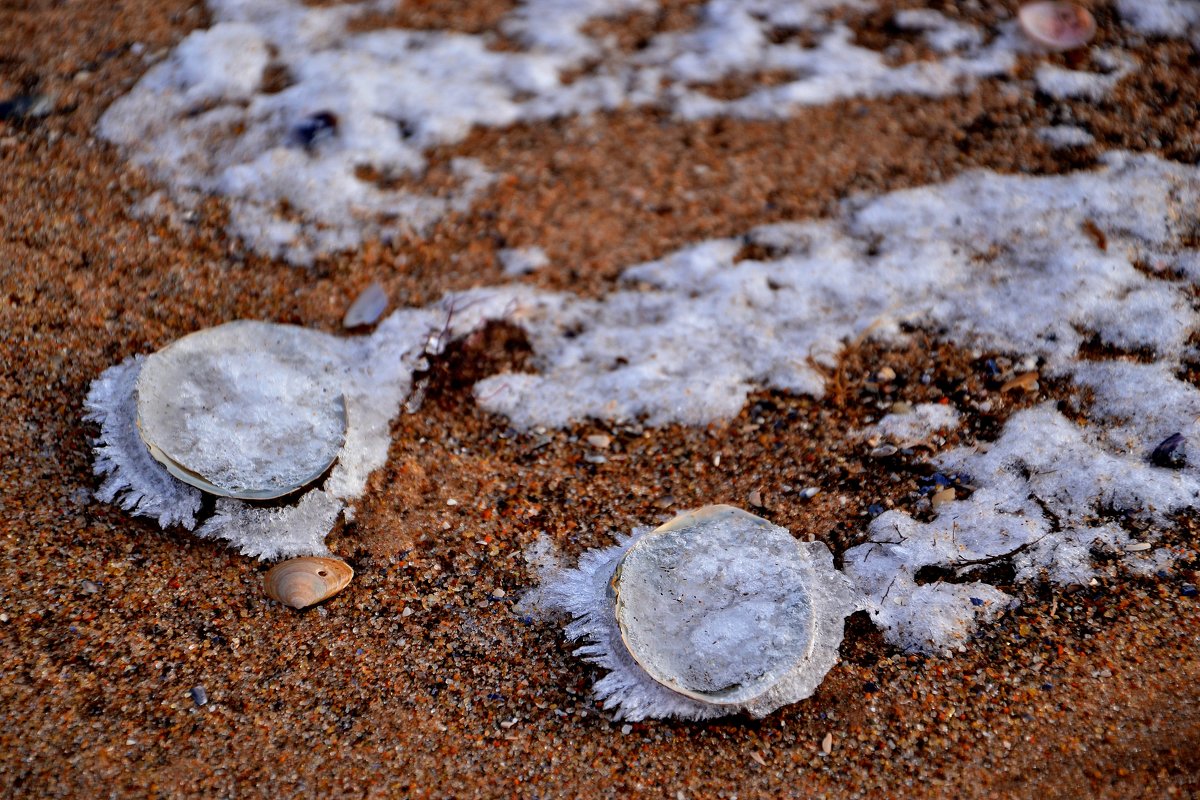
[458,154,1200,652]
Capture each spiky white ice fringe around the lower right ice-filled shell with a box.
[529,528,860,721]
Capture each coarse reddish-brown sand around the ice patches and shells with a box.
[0,0,1200,798]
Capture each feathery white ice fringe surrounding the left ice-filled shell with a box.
[86,307,446,559]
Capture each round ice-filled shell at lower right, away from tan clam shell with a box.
[610,505,858,711]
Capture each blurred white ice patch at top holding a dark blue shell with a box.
[100,0,1041,264]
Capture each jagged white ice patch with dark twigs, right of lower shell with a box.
[844,402,1200,650]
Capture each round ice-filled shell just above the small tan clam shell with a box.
[137,320,346,500]
